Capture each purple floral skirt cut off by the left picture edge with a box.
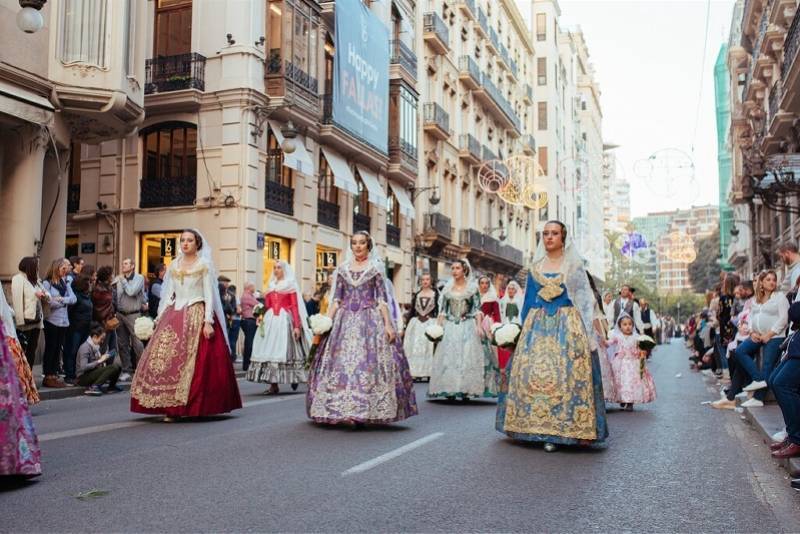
[0,325,42,477]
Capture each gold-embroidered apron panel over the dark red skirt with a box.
[131,302,205,408]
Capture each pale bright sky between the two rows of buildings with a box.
[560,0,735,216]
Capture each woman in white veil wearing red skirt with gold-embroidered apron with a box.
[131,230,242,422]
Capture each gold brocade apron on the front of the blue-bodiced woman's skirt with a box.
[503,307,597,440]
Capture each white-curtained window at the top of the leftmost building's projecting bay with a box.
[60,0,109,69]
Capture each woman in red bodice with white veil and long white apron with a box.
[247,260,312,395]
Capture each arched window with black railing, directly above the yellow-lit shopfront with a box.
[139,122,197,208]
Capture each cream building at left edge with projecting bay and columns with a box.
[0,0,146,280]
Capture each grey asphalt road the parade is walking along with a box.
[0,341,800,532]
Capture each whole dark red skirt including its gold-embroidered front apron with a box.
[131,303,242,417]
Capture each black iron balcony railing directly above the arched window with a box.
[144,52,206,95]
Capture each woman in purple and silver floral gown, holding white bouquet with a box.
[306,232,417,425]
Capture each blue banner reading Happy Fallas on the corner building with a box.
[332,0,389,153]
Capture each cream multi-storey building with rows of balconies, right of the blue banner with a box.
[415,0,537,284]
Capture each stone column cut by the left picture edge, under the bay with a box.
[0,124,49,278]
